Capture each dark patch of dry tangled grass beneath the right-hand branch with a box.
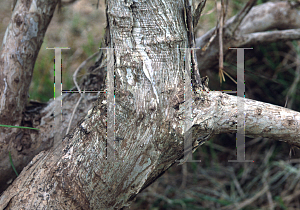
[129,135,300,210]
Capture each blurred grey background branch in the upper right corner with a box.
[196,2,300,72]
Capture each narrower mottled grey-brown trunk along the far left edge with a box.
[0,0,57,192]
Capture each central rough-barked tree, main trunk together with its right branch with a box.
[0,0,300,209]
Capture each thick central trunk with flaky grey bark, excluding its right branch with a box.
[1,1,193,209]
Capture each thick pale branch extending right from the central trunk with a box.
[193,91,300,147]
